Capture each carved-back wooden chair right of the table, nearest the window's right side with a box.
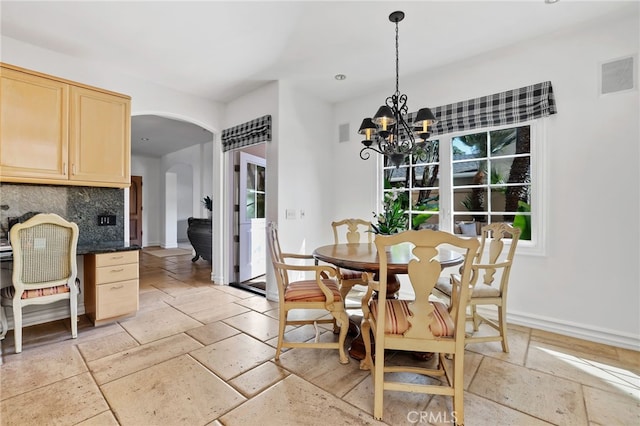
[434,223,520,352]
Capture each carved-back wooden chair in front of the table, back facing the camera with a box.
[360,229,479,424]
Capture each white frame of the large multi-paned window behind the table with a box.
[377,119,549,256]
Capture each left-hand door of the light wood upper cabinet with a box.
[0,68,69,181]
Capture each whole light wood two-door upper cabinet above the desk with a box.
[0,64,131,188]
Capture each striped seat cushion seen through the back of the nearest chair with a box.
[369,299,455,337]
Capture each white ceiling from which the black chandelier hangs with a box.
[0,0,637,155]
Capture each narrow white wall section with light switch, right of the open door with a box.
[278,82,336,254]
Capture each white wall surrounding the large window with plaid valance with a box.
[332,9,640,349]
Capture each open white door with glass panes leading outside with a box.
[238,152,267,283]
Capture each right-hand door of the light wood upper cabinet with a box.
[69,86,131,185]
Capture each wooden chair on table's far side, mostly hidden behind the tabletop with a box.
[331,219,374,309]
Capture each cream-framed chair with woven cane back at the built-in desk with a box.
[0,214,78,353]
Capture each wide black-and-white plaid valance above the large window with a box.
[408,81,557,136]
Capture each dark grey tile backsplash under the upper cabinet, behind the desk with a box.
[0,183,124,245]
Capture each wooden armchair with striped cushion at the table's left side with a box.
[267,223,349,364]
